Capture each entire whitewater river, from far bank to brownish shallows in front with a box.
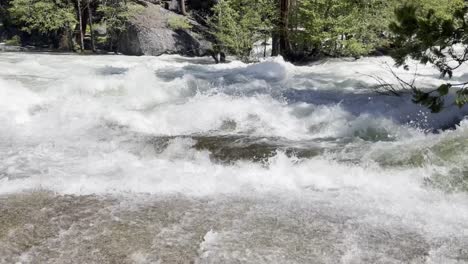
[0,53,468,264]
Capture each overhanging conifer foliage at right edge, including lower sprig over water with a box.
[390,0,468,112]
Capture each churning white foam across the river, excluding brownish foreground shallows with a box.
[0,53,468,241]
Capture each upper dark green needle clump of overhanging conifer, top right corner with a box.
[390,2,468,74]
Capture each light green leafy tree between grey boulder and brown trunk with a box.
[210,0,277,61]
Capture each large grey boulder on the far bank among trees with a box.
[118,3,211,56]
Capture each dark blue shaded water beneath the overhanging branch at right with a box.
[283,89,468,133]
